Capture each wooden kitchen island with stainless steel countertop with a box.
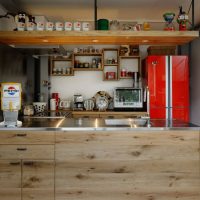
[0,118,200,200]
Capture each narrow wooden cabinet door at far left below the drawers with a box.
[0,160,21,200]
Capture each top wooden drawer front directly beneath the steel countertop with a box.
[0,131,54,144]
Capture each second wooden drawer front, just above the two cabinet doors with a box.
[0,145,54,160]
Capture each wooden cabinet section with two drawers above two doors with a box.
[0,131,55,200]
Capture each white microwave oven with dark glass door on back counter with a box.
[114,87,143,110]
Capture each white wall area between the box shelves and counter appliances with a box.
[51,71,133,99]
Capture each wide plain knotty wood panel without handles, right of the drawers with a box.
[55,131,200,200]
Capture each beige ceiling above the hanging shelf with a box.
[0,0,200,24]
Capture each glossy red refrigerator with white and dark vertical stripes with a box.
[145,56,189,122]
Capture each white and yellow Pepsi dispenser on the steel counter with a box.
[0,83,22,127]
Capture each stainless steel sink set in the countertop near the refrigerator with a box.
[105,118,147,126]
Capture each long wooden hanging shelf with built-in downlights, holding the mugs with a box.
[0,31,199,45]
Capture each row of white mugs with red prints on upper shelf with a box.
[17,22,91,31]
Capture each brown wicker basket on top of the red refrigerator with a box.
[147,46,176,56]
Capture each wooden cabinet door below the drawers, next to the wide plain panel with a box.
[22,160,54,200]
